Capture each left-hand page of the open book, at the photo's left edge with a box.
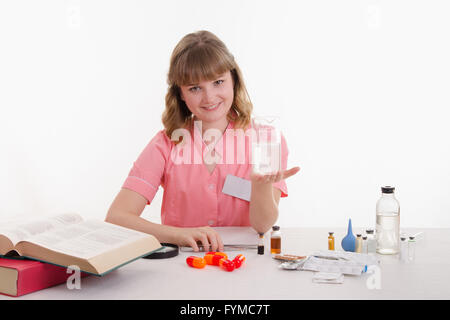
[0,212,83,246]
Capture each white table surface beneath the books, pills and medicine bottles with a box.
[0,228,450,300]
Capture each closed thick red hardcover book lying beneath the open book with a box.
[0,258,85,297]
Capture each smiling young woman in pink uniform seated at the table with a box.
[106,31,300,251]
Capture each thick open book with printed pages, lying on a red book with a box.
[0,213,162,276]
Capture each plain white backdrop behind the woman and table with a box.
[0,0,450,227]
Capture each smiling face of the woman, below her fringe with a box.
[180,71,234,124]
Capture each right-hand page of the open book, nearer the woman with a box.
[26,220,149,260]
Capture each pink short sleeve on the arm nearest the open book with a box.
[122,130,172,204]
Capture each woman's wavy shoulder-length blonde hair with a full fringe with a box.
[162,30,253,138]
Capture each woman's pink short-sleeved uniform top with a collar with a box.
[122,122,288,227]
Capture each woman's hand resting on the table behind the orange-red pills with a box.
[175,226,223,252]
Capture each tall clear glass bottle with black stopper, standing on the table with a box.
[376,186,400,254]
